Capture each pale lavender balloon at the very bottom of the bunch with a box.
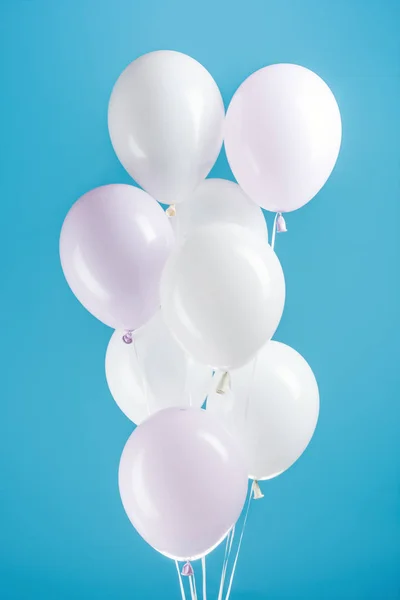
[119,408,247,560]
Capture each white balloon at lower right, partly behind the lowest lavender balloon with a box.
[207,341,319,479]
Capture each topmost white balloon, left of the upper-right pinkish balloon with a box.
[108,50,225,204]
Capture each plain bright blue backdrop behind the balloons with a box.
[0,0,400,600]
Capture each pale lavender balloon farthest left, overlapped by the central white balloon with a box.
[60,184,174,330]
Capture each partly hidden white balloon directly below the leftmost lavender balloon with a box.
[106,312,212,425]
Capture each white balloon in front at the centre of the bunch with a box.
[161,223,285,369]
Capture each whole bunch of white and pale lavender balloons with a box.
[60,51,341,597]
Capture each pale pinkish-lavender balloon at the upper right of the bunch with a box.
[225,64,342,212]
